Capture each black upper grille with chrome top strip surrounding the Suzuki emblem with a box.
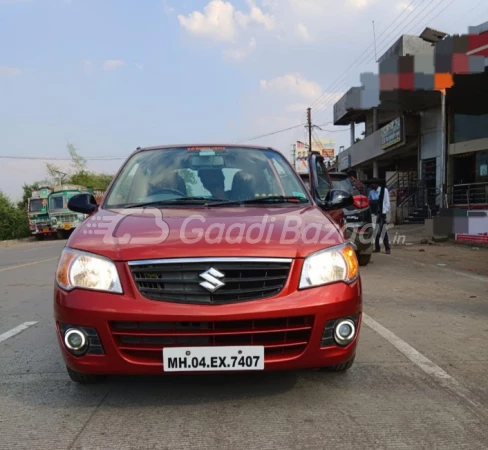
[130,260,291,305]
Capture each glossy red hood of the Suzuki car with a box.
[67,205,344,261]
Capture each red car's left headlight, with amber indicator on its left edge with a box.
[56,248,123,294]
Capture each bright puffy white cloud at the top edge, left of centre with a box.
[178,0,236,41]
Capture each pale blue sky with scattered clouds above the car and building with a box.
[0,0,488,199]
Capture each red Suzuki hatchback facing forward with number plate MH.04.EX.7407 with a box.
[54,145,362,383]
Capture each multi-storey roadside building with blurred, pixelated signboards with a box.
[334,23,488,223]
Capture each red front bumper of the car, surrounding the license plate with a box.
[54,279,362,375]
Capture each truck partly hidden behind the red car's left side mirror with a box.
[49,184,89,239]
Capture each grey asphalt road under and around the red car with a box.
[0,237,488,450]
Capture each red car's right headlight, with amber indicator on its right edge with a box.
[299,244,359,289]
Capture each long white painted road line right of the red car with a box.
[363,313,484,413]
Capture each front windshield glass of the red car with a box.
[104,147,309,208]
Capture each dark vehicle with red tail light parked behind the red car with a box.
[301,172,374,266]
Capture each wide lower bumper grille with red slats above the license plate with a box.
[110,316,314,364]
